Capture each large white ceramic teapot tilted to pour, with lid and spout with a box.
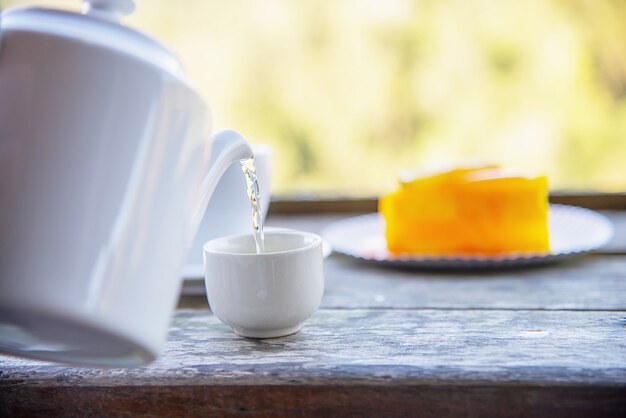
[0,0,252,366]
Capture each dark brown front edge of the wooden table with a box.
[0,384,626,418]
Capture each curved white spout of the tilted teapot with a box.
[190,129,253,235]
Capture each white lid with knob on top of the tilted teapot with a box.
[0,0,184,78]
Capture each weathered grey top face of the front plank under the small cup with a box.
[0,310,626,388]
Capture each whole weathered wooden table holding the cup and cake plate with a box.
[0,212,626,418]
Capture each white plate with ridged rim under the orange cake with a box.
[322,205,613,270]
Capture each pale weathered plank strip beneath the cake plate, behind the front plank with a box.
[181,255,626,310]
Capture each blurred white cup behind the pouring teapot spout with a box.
[183,144,272,277]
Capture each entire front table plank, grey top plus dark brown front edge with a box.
[0,310,626,418]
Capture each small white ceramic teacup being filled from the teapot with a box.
[204,229,324,338]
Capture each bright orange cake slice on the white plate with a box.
[379,165,550,256]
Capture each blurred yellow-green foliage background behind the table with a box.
[2,0,626,197]
